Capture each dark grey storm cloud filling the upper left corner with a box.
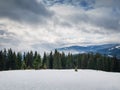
[0,0,53,23]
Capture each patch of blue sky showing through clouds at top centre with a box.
[43,0,95,10]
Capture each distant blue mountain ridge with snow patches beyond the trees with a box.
[57,44,120,58]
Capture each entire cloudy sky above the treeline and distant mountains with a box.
[0,0,120,51]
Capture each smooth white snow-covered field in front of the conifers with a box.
[0,70,120,90]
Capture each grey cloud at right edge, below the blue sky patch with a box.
[68,11,120,32]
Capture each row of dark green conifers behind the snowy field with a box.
[0,49,120,72]
